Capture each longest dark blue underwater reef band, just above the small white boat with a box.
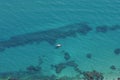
[0,23,92,51]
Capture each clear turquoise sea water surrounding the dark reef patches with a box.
[0,0,120,80]
